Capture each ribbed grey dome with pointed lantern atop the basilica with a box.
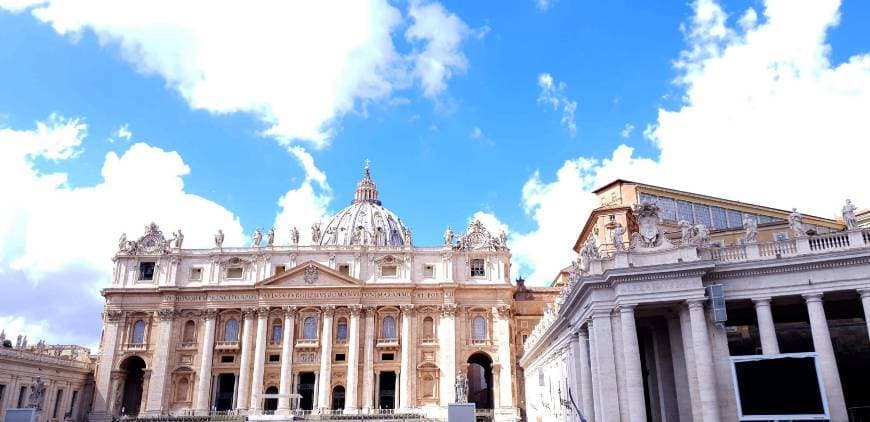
[320,161,411,246]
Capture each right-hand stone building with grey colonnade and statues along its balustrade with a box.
[520,181,870,422]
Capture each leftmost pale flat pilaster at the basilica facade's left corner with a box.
[93,311,123,419]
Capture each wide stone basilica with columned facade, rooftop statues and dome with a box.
[91,164,558,421]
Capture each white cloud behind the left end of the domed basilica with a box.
[0,115,244,344]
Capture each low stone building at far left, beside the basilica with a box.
[0,332,94,422]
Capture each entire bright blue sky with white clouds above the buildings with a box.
[0,0,870,346]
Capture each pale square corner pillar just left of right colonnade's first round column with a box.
[591,309,622,422]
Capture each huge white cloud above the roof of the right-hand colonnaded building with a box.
[511,0,870,284]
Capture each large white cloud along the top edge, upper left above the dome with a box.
[0,0,475,147]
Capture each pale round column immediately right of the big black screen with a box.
[803,293,849,421]
